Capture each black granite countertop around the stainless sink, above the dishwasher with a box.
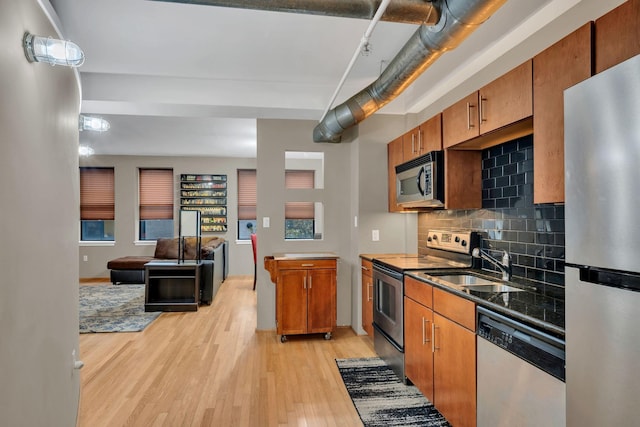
[405,269,565,339]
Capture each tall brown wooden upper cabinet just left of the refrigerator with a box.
[533,23,593,203]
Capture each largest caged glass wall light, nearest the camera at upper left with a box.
[22,33,84,67]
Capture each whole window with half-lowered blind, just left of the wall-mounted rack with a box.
[138,168,174,240]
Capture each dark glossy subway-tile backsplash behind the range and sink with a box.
[418,135,565,290]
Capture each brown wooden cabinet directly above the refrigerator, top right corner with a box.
[595,0,640,73]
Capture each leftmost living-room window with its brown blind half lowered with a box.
[80,167,115,241]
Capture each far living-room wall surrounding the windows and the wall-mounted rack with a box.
[76,156,256,278]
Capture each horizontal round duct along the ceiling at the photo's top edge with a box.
[155,0,438,25]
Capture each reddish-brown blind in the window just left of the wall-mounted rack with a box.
[140,169,173,220]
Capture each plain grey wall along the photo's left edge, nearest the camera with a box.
[0,0,80,426]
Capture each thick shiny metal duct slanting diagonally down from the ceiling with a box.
[313,0,507,142]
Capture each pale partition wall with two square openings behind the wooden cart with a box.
[257,120,357,330]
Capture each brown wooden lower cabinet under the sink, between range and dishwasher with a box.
[404,277,476,427]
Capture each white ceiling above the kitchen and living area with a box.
[50,0,623,157]
